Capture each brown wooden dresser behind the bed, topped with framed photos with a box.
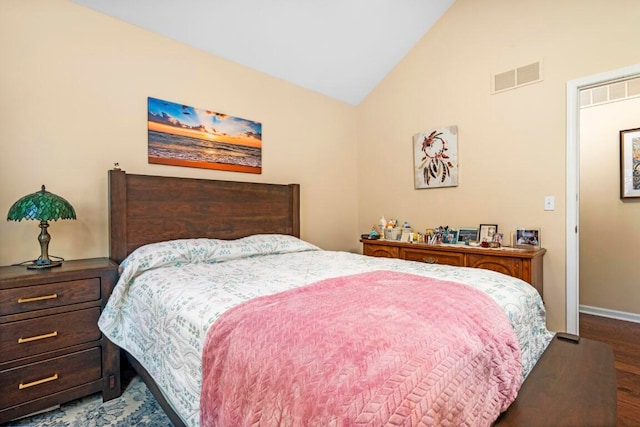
[361,239,546,296]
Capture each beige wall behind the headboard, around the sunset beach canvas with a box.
[0,0,358,265]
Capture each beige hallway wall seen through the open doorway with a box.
[580,98,640,314]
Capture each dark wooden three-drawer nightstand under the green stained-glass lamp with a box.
[0,258,121,423]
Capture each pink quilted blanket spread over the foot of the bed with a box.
[200,271,521,426]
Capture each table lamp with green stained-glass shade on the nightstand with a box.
[7,185,76,269]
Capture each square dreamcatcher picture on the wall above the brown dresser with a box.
[413,125,459,190]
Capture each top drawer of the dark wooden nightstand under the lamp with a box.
[0,277,100,316]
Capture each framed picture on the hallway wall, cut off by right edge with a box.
[620,128,640,199]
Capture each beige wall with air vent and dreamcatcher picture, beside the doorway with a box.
[358,0,640,330]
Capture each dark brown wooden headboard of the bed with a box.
[109,169,300,263]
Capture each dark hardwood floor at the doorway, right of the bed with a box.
[580,314,640,426]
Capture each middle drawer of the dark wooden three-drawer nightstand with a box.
[0,307,101,362]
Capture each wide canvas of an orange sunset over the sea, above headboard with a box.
[147,97,262,174]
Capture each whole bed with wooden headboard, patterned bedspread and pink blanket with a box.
[100,170,553,426]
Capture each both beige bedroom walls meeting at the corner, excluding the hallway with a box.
[0,0,640,330]
